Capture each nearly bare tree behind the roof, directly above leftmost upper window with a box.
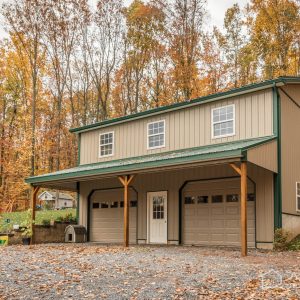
[84,0,124,122]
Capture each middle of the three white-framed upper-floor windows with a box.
[147,120,165,149]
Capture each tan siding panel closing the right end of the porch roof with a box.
[247,140,278,173]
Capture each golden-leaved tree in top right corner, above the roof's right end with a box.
[248,0,300,78]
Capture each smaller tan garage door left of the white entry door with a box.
[90,189,137,244]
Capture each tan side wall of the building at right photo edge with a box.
[280,85,300,223]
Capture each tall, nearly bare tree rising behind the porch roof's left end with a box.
[42,0,89,170]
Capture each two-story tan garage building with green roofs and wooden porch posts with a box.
[26,77,300,253]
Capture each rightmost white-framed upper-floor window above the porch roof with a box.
[211,104,235,138]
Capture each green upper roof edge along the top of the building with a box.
[69,76,300,133]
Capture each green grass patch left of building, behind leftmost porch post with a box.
[0,208,76,232]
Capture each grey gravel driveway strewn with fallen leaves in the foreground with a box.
[0,244,300,300]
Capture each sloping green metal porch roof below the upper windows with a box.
[25,136,275,184]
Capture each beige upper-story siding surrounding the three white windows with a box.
[80,89,273,164]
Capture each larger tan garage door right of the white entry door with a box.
[182,179,255,247]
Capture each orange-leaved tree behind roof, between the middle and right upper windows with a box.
[160,0,206,101]
